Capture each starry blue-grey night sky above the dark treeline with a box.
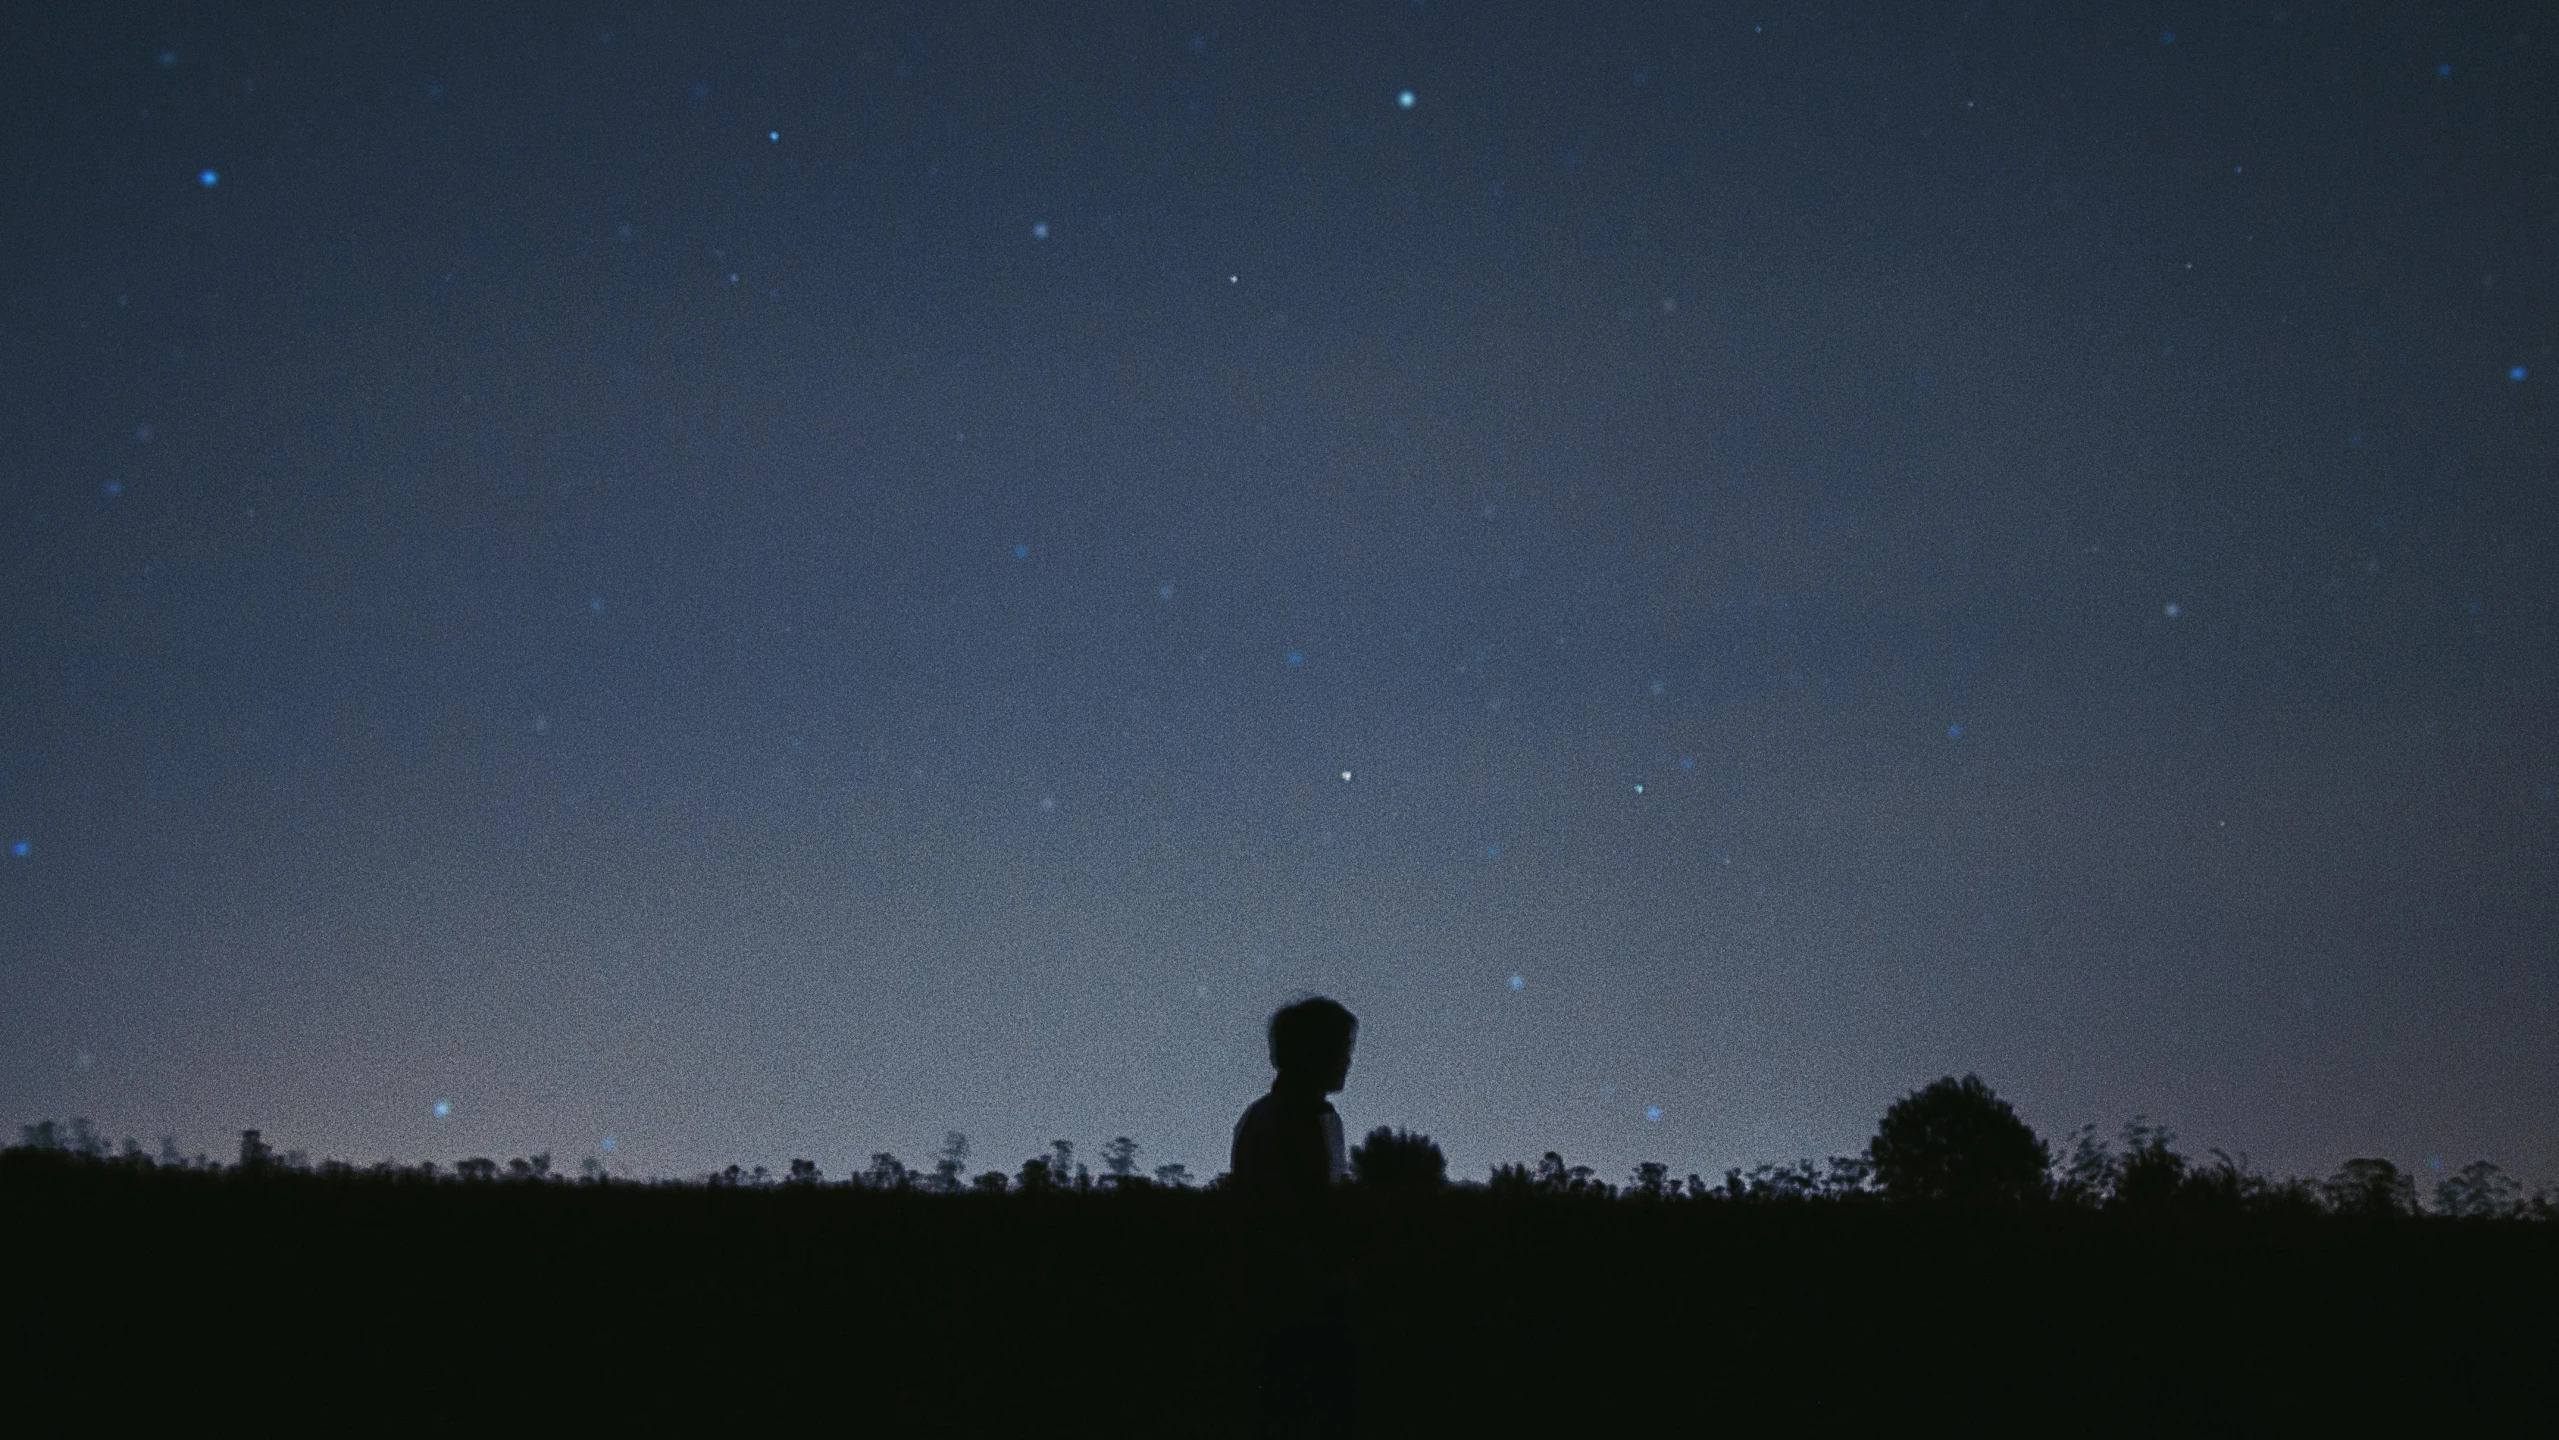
[0,0,2559,1182]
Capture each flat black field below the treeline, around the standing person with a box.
[0,1151,2559,1435]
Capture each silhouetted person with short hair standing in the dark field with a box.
[1228,998,1359,1435]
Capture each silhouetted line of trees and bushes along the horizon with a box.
[13,1074,2559,1220]
